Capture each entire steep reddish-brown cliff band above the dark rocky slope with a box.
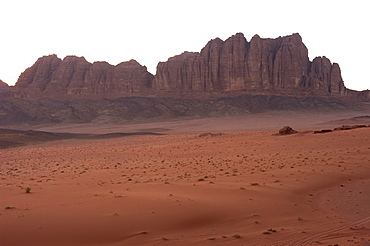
[10,33,369,99]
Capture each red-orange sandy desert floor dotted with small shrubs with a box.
[0,114,370,246]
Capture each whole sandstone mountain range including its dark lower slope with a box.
[0,33,370,125]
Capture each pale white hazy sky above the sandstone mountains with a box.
[0,0,370,90]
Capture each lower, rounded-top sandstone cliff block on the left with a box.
[15,55,153,96]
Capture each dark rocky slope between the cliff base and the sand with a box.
[0,95,349,125]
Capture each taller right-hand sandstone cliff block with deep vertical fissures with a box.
[153,33,345,95]
